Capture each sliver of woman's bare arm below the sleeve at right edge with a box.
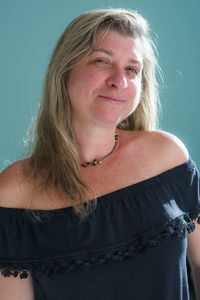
[187,219,200,300]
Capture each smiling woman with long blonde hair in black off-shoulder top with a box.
[0,9,200,300]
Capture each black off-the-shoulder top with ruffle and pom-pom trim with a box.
[0,158,200,300]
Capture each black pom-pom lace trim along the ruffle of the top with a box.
[0,208,200,279]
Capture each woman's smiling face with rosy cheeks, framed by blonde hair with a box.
[67,31,143,128]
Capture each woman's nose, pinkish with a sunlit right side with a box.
[106,69,127,89]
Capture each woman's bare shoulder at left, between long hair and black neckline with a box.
[0,159,66,210]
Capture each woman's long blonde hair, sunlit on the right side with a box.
[24,9,161,219]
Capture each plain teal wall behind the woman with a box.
[0,0,200,170]
